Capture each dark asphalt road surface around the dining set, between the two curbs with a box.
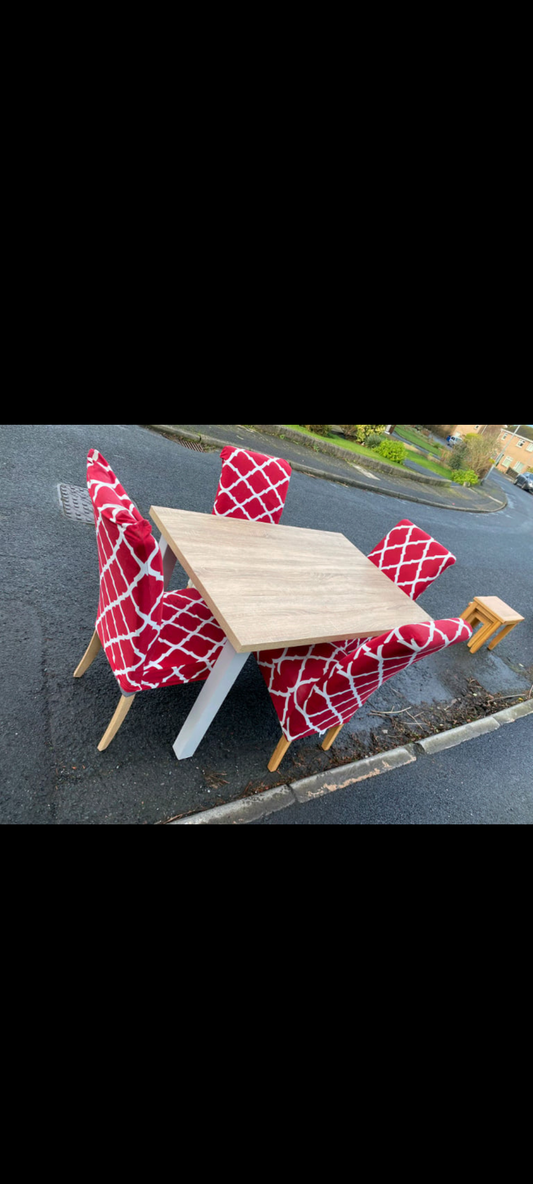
[0,424,533,824]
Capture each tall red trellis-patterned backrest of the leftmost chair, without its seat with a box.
[86,449,163,691]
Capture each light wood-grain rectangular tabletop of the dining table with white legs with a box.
[150,506,432,652]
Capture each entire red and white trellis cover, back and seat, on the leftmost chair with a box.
[86,449,225,693]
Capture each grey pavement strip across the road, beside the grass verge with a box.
[146,424,507,514]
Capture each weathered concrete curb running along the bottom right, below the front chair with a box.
[167,699,533,826]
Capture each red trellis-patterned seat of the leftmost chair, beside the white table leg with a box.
[141,588,225,689]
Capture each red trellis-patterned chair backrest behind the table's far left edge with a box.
[213,444,291,522]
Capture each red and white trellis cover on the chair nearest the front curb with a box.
[256,617,473,740]
